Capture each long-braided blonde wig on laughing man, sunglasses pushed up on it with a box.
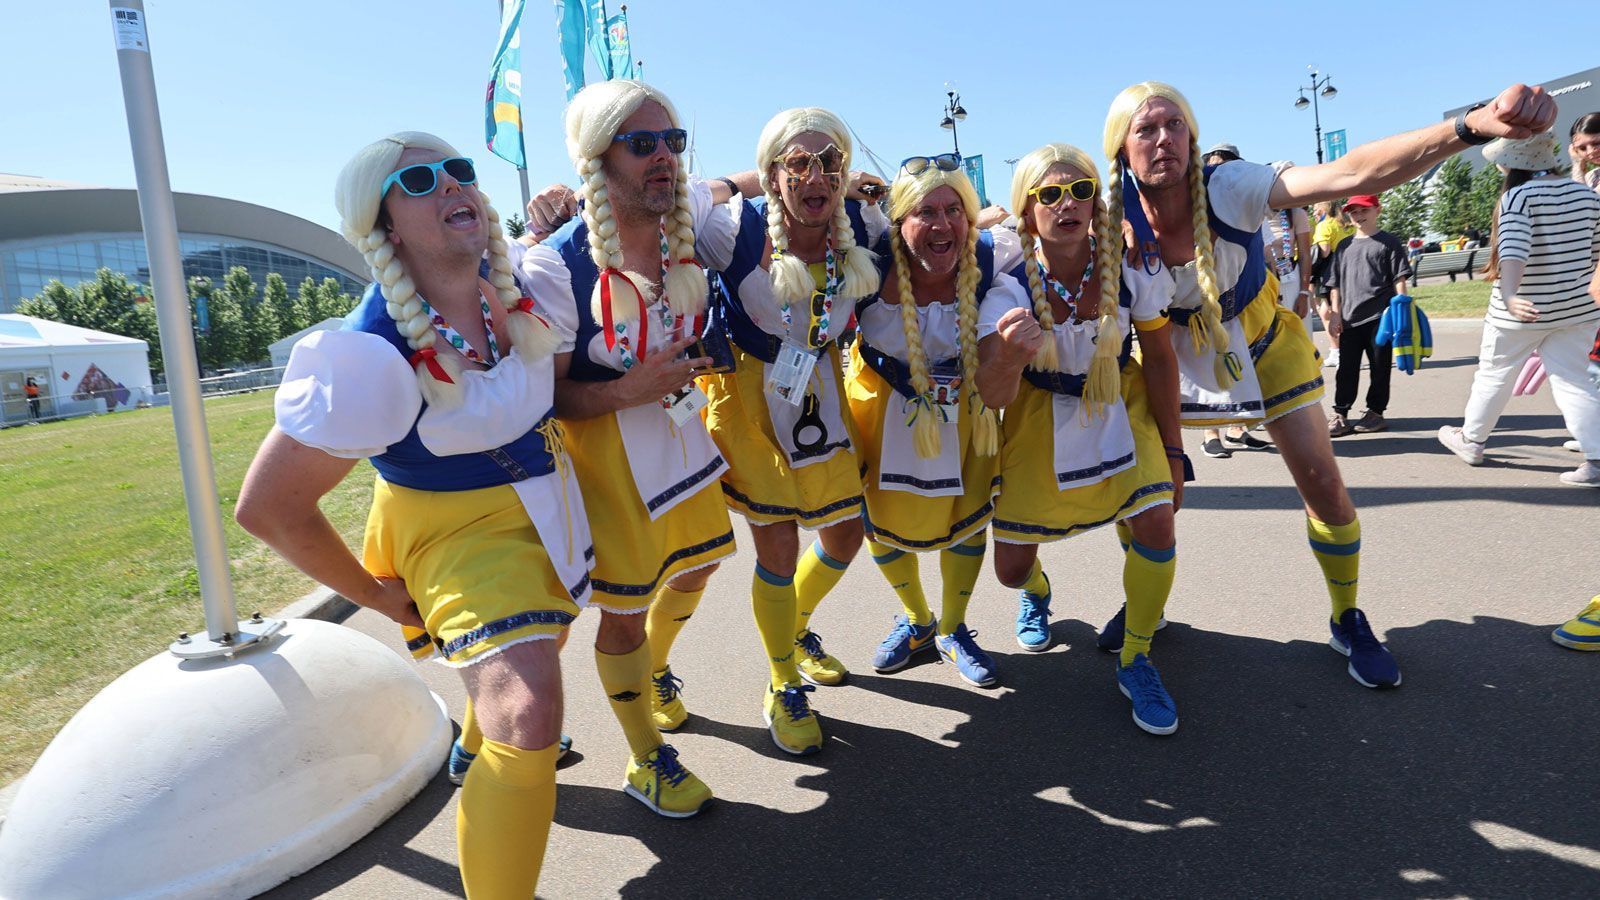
[890,165,1000,460]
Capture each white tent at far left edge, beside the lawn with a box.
[0,314,150,424]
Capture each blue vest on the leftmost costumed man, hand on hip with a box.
[344,283,555,490]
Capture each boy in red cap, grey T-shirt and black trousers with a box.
[1323,194,1411,437]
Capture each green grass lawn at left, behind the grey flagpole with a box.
[0,391,373,785]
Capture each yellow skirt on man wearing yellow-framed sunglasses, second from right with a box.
[994,360,1173,544]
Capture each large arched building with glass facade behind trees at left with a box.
[0,175,368,312]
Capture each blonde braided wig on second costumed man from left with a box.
[566,80,706,325]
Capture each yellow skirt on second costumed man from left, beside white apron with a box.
[562,406,734,613]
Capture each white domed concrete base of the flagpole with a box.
[0,620,451,900]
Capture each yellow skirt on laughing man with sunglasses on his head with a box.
[845,343,1000,552]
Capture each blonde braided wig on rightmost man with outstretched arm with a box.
[1106,82,1238,388]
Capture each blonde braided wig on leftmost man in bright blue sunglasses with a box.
[333,131,558,407]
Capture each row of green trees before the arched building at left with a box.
[16,266,357,376]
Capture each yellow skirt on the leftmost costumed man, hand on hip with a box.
[362,477,582,666]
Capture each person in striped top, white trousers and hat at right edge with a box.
[1438,131,1600,487]
